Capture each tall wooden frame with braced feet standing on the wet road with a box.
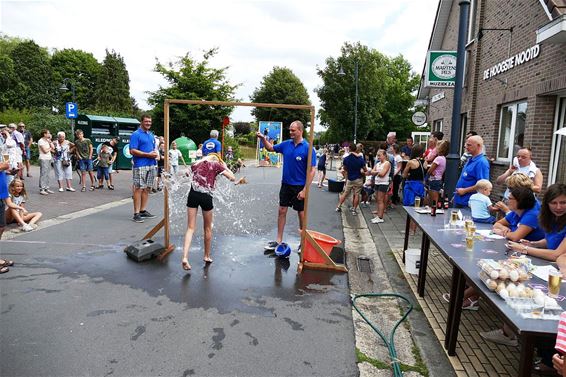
[143,99,345,272]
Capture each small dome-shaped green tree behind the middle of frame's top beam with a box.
[251,67,311,139]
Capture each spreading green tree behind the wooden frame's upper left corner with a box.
[148,49,237,144]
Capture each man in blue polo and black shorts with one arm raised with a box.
[256,120,316,250]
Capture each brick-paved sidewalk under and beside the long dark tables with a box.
[356,203,519,377]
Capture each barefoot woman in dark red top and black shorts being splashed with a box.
[181,153,244,271]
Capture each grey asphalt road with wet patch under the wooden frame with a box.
[0,163,358,376]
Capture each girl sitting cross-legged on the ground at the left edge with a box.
[6,178,43,232]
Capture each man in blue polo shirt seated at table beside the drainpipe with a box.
[454,135,489,208]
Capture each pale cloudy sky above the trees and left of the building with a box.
[0,0,438,128]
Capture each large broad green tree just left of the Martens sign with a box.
[315,42,418,142]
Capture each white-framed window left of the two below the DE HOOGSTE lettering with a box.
[497,102,527,161]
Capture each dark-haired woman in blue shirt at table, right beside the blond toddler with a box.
[493,187,544,242]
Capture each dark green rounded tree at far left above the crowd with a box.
[7,40,56,109]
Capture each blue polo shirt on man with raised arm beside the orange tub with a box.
[273,139,316,186]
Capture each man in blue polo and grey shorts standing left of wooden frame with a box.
[130,114,158,223]
